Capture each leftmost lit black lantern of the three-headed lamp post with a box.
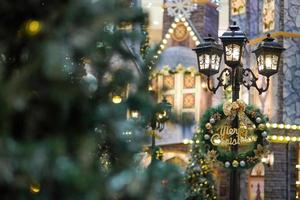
[193,35,223,76]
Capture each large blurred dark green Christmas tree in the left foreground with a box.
[0,0,183,199]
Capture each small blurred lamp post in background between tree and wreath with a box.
[149,97,172,162]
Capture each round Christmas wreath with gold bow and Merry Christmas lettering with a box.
[193,100,269,169]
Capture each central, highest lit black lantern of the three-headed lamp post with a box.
[220,22,247,68]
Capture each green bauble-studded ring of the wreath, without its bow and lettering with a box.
[197,101,269,169]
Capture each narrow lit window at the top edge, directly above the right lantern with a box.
[262,0,275,32]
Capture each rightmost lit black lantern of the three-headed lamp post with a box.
[253,34,285,77]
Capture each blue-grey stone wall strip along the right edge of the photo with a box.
[283,0,300,124]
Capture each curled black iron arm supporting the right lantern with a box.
[243,68,270,94]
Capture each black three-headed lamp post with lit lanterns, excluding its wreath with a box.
[193,23,284,200]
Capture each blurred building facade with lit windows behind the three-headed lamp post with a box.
[141,0,300,200]
